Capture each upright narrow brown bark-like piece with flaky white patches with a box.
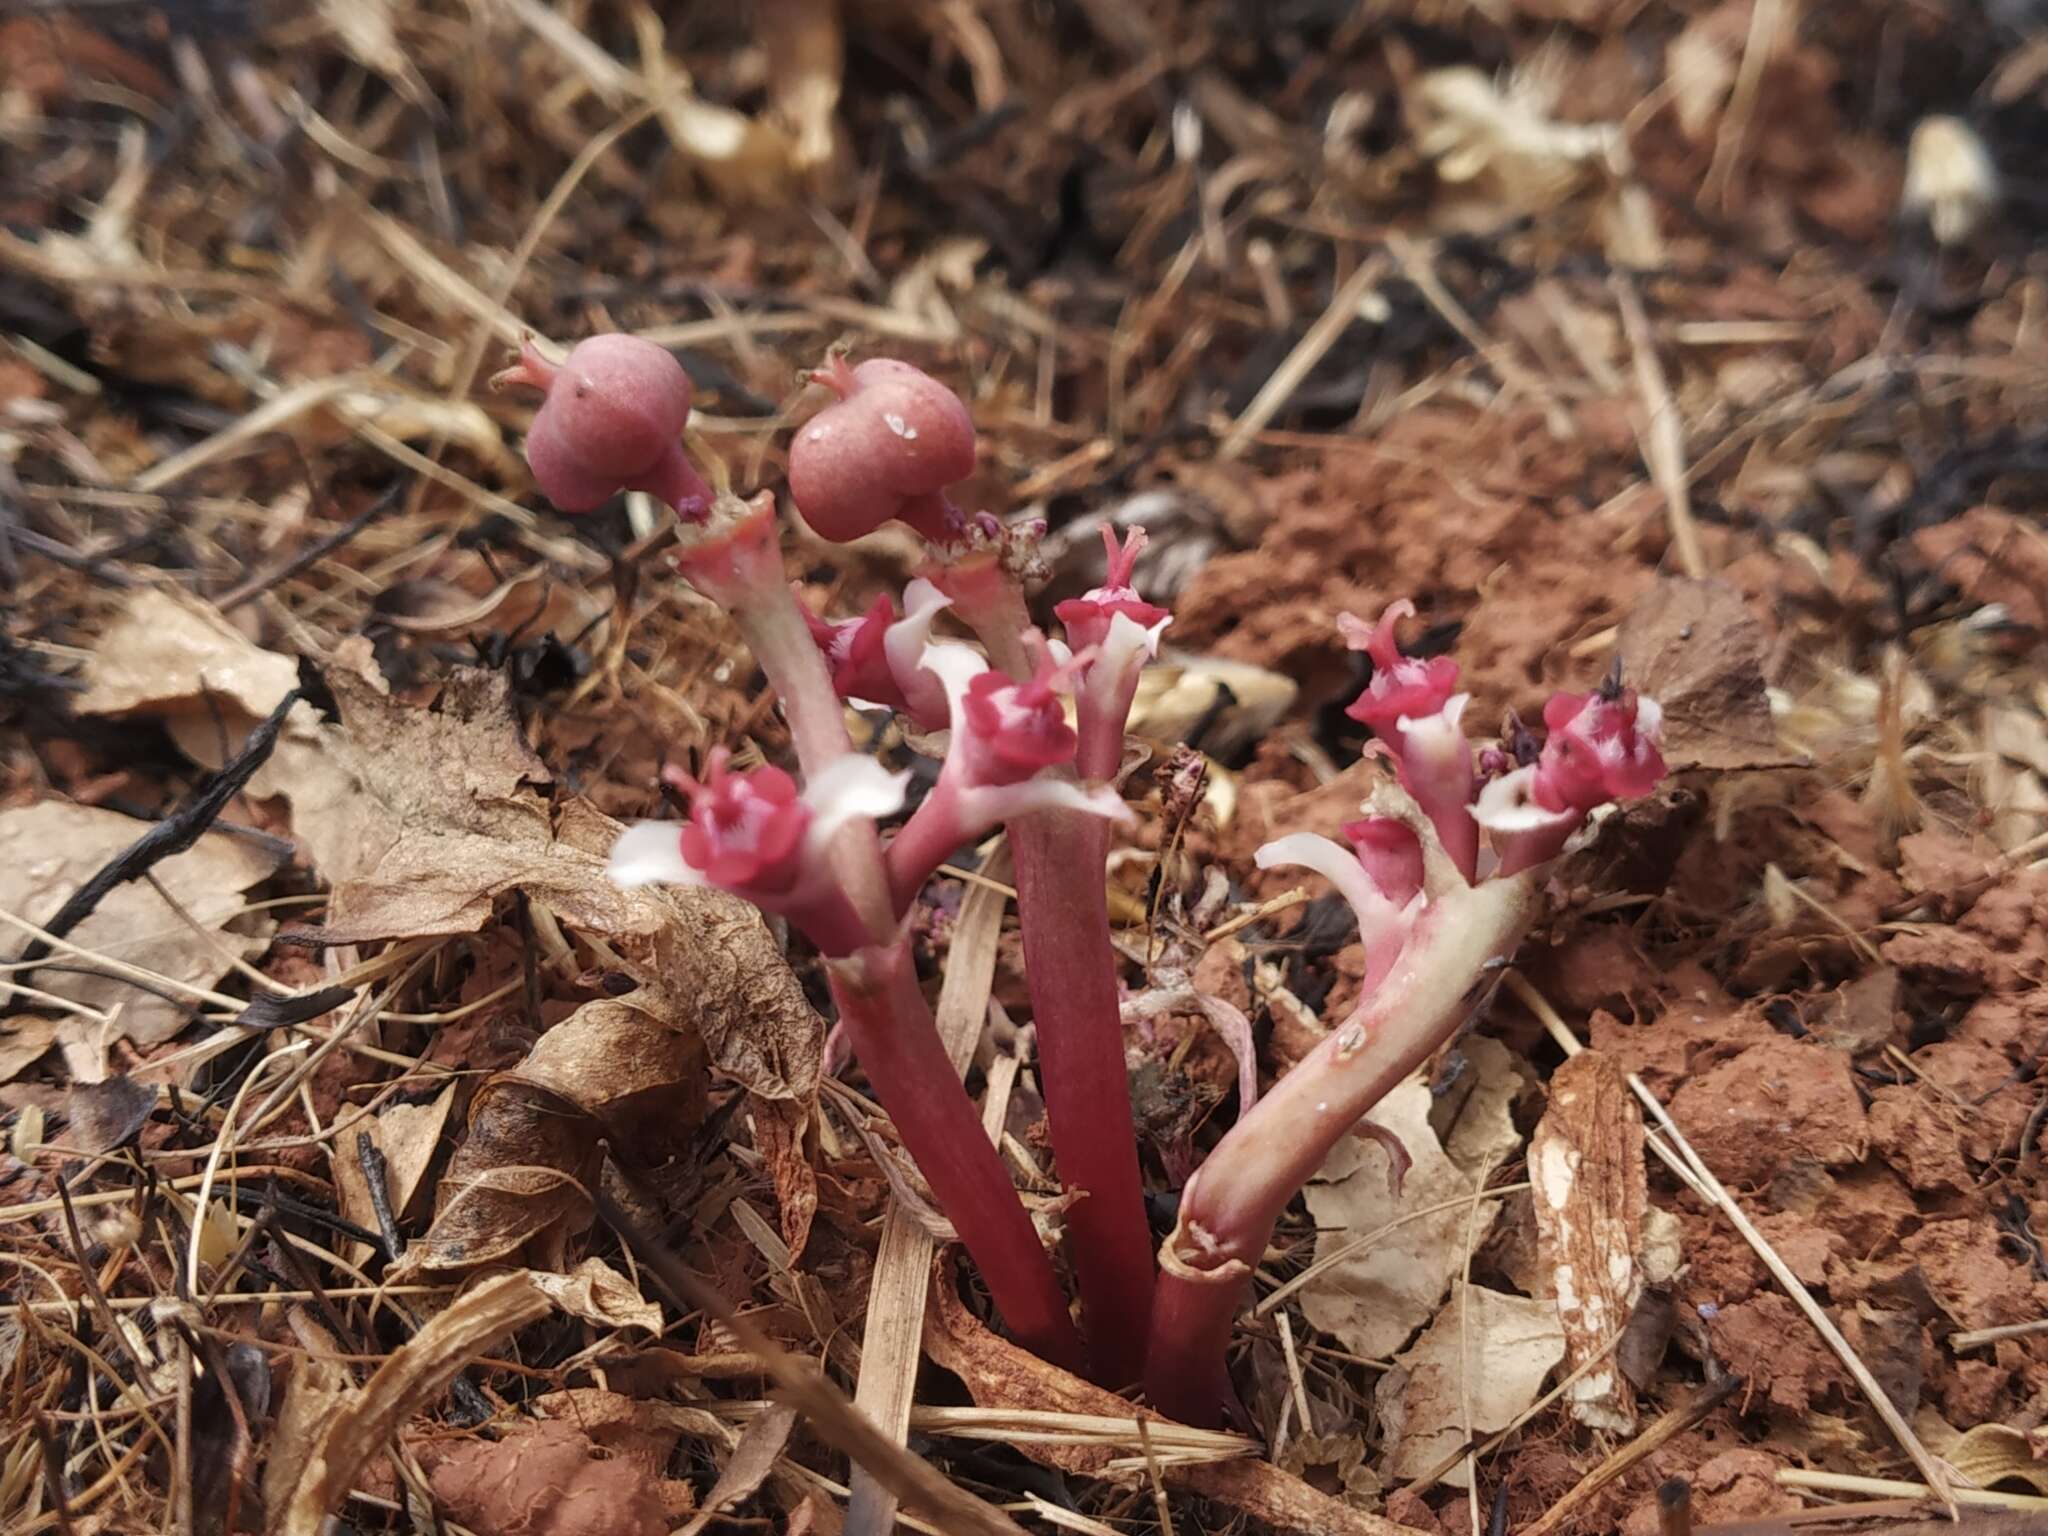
[1528,1051,1649,1434]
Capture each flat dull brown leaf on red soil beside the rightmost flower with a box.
[1618,575,1800,772]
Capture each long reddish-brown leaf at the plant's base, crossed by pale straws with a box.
[924,1255,1419,1536]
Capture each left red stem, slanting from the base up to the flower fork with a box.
[829,942,1081,1370]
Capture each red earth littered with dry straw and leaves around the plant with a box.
[0,0,2048,1536]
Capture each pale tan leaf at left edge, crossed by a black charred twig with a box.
[0,801,279,1055]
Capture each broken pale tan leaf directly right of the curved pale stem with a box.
[1300,1036,1520,1358]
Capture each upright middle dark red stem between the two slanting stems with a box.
[1010,811,1153,1386]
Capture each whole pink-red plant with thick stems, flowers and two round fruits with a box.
[500,336,1665,1423]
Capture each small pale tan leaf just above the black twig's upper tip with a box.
[78,588,299,729]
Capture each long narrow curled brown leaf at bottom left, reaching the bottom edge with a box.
[276,1274,549,1536]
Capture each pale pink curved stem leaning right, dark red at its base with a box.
[1145,874,1536,1423]
